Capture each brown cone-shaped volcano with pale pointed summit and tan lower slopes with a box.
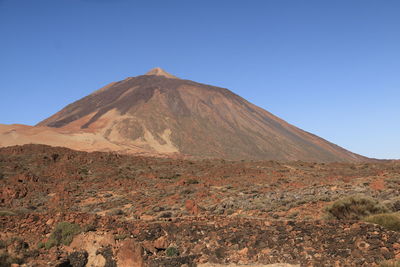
[0,68,366,161]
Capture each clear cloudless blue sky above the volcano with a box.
[0,0,400,158]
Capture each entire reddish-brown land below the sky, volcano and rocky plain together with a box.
[0,68,400,267]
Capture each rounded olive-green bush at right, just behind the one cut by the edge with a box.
[326,196,389,220]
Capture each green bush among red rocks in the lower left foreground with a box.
[45,222,81,249]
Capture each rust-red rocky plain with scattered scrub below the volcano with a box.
[0,145,400,266]
